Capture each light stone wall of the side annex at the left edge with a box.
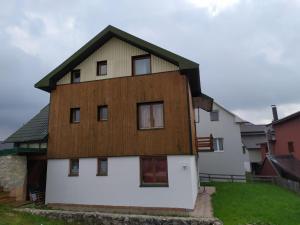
[0,155,27,200]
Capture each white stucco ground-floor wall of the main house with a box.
[46,156,198,209]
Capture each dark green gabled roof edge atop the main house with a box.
[35,25,201,96]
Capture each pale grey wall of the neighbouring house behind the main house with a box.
[195,103,249,175]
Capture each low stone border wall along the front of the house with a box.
[16,208,223,225]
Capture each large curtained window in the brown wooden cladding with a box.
[138,102,164,129]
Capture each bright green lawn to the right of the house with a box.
[211,182,300,225]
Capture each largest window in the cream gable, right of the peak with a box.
[132,55,151,75]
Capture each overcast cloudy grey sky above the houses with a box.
[0,0,300,140]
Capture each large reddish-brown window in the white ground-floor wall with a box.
[140,156,168,186]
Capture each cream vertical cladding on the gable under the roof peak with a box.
[57,38,179,85]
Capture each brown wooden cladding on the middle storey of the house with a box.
[48,71,195,158]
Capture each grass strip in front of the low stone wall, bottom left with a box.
[0,205,80,225]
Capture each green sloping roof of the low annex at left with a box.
[5,105,49,143]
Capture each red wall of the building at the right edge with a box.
[273,116,300,160]
